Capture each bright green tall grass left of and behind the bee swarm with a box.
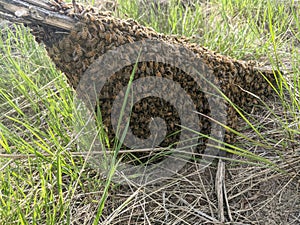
[0,0,300,225]
